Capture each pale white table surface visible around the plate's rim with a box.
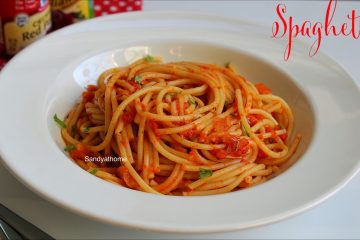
[0,0,360,239]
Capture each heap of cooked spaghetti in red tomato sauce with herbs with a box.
[54,55,300,195]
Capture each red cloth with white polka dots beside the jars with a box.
[94,0,143,17]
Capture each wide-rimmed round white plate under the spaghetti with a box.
[0,12,360,232]
